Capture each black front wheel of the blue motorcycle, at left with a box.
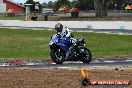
[50,49,65,64]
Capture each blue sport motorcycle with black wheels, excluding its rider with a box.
[49,35,92,64]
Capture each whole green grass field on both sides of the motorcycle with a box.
[0,29,132,60]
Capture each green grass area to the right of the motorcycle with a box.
[73,33,132,57]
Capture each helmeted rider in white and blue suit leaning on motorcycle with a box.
[55,23,76,59]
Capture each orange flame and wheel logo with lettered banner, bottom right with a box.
[80,68,131,86]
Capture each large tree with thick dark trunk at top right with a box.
[94,0,132,16]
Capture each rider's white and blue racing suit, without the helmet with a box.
[57,27,76,60]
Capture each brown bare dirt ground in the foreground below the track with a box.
[0,67,132,88]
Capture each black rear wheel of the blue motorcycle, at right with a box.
[80,47,92,63]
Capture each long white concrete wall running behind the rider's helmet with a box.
[0,20,132,30]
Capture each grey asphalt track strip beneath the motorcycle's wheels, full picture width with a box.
[0,60,132,68]
